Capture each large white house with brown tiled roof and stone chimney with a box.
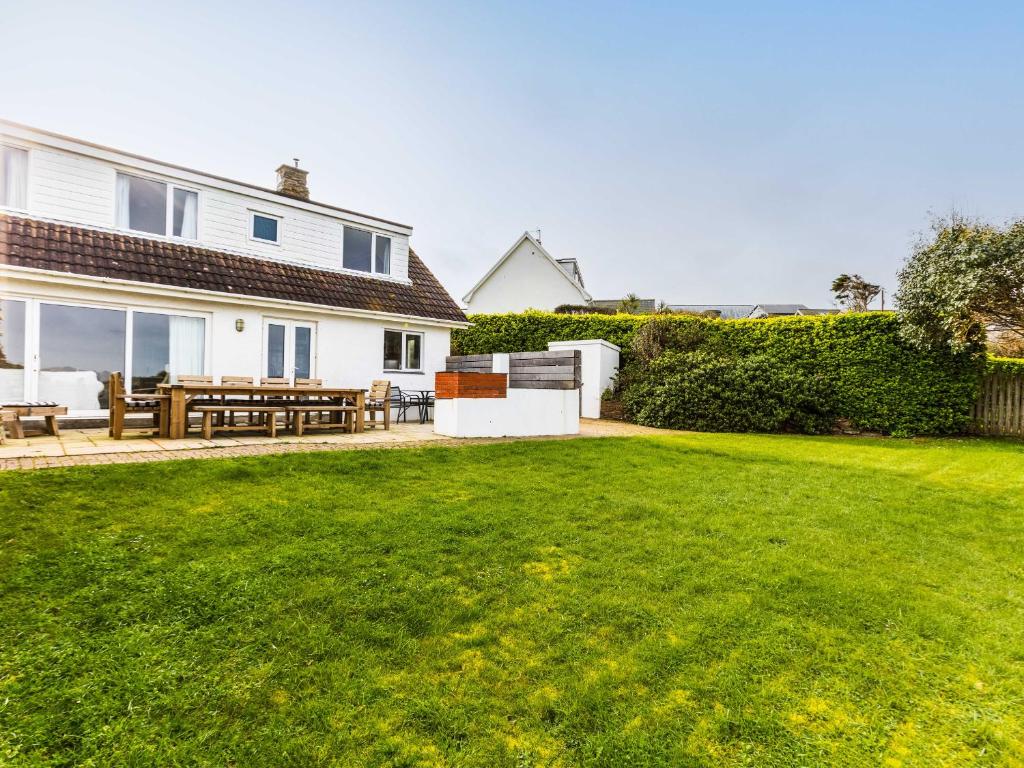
[0,121,468,416]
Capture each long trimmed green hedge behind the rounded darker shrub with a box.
[453,311,984,435]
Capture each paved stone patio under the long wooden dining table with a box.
[0,419,664,470]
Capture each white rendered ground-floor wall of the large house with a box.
[0,273,451,416]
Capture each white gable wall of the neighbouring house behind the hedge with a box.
[466,240,587,313]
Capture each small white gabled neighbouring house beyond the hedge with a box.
[463,232,591,313]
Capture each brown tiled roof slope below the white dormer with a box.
[0,215,466,323]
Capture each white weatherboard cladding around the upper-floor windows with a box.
[6,131,411,281]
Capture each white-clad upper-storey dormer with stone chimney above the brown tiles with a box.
[0,121,413,283]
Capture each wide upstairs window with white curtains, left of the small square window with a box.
[117,173,199,240]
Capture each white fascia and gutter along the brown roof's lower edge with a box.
[0,264,472,328]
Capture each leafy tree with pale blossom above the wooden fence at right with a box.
[896,214,1024,351]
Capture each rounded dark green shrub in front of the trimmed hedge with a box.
[623,351,836,434]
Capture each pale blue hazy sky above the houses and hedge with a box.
[8,0,1024,305]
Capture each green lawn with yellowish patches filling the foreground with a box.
[0,434,1024,767]
